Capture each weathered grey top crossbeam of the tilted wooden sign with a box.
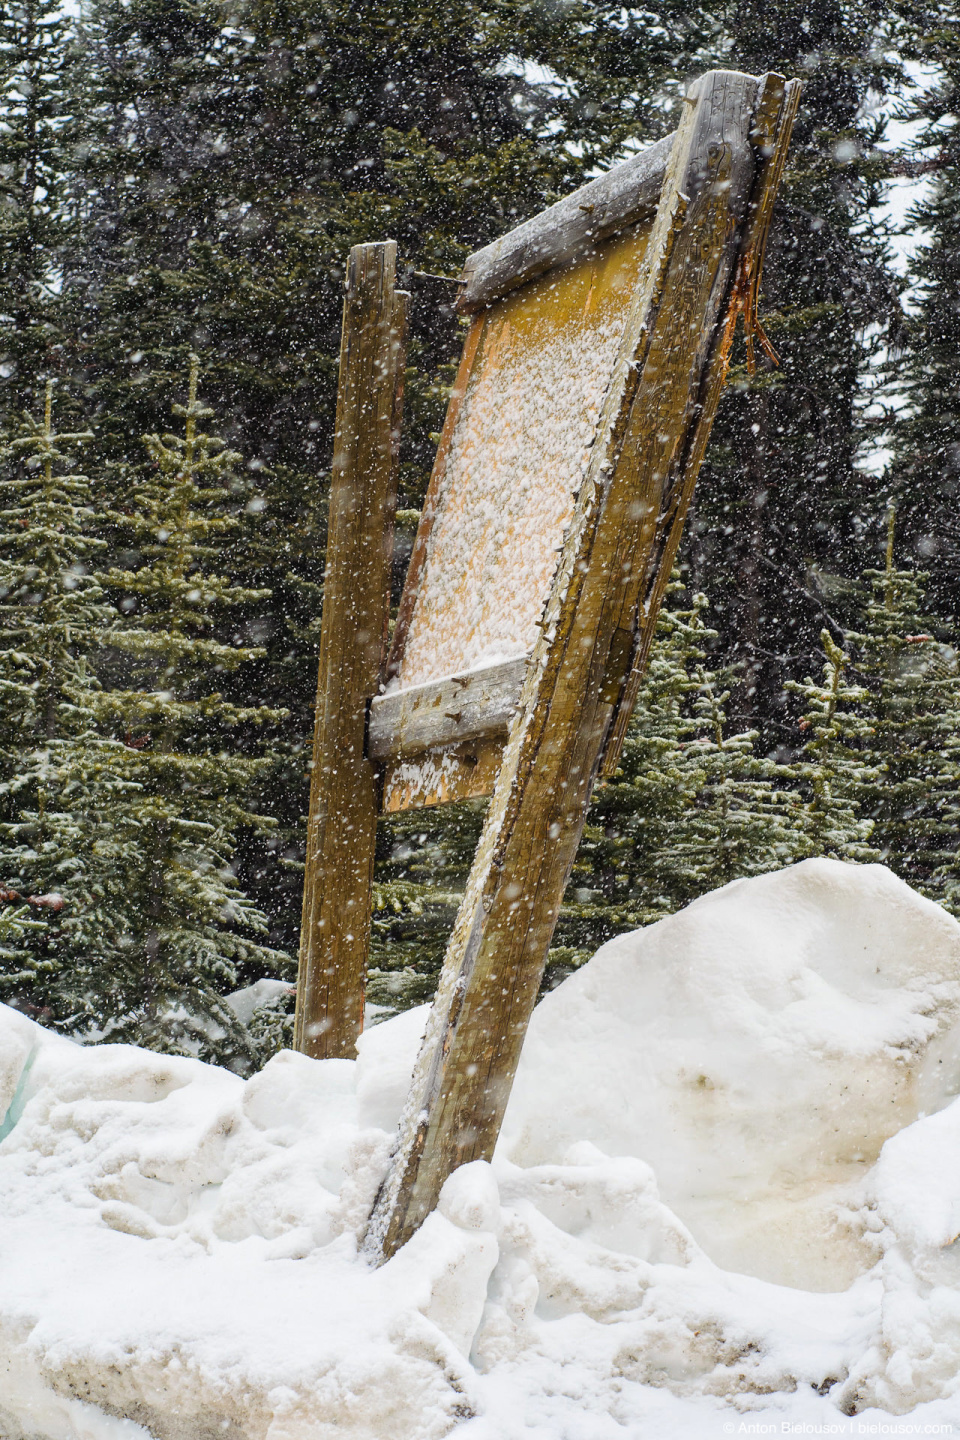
[458,135,674,314]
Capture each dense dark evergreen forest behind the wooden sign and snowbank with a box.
[0,0,960,1054]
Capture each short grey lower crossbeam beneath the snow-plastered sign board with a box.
[367,655,527,760]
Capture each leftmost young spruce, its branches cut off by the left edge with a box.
[0,383,142,1032]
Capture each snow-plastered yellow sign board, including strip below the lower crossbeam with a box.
[374,222,651,809]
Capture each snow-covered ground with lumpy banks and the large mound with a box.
[0,861,960,1440]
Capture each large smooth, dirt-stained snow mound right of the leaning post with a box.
[501,860,960,1290]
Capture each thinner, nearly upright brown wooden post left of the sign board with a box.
[294,240,409,1060]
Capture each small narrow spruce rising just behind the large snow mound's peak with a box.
[787,629,882,861]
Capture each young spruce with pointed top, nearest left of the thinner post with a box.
[91,356,288,1060]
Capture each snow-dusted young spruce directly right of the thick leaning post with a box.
[551,583,803,968]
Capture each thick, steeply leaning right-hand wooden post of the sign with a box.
[364,72,794,1257]
